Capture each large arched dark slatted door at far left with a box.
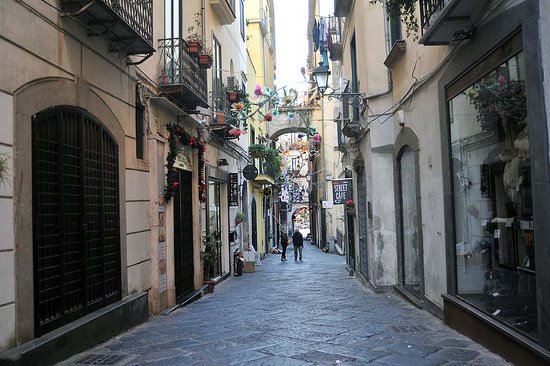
[32,107,121,335]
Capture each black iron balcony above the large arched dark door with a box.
[61,0,155,55]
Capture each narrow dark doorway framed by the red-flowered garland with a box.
[174,170,195,300]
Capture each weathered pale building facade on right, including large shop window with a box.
[331,0,550,364]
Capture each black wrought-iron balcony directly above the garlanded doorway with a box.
[159,38,208,111]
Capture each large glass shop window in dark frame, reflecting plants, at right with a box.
[449,52,537,338]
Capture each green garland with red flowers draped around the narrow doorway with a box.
[164,122,206,202]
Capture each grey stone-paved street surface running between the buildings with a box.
[58,244,510,366]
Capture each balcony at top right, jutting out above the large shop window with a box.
[420,0,485,46]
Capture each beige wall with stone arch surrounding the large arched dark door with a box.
[0,1,155,347]
